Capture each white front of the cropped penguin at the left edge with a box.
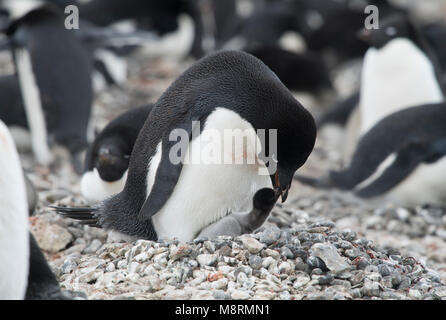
[0,121,29,300]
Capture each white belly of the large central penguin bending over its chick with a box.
[152,108,272,241]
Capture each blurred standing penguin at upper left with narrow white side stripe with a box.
[6,5,92,164]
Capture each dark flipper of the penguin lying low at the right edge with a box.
[355,139,446,198]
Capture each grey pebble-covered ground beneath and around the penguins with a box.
[8,0,446,300]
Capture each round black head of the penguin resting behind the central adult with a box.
[93,137,130,182]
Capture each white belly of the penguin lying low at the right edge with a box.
[387,157,446,206]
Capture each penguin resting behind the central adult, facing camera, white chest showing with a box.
[81,105,152,201]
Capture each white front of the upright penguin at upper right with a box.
[360,38,444,134]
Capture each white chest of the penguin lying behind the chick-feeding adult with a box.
[81,168,127,202]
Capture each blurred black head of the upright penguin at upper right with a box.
[358,14,420,49]
